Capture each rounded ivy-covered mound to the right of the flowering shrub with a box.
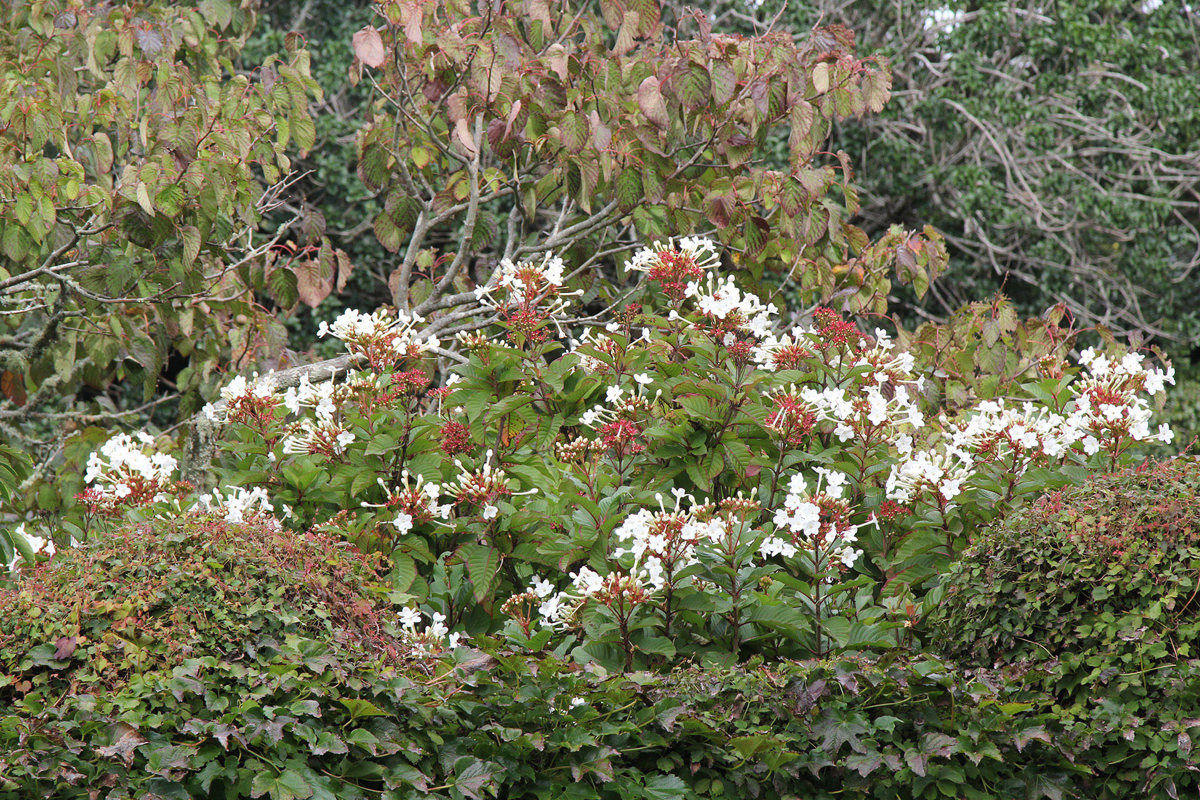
[932,457,1200,796]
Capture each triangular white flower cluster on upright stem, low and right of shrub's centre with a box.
[758,467,872,567]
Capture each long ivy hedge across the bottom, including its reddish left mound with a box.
[7,499,1200,800]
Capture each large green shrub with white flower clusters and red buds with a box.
[14,237,1174,669]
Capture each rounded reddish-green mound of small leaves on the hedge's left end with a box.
[0,516,409,693]
